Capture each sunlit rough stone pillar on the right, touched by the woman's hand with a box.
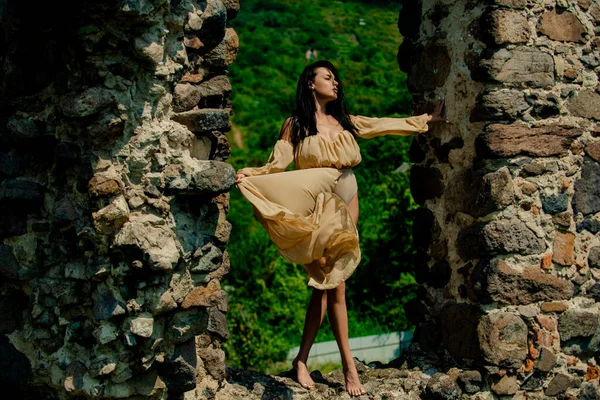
[398,0,600,399]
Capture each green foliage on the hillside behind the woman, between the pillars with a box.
[225,0,416,371]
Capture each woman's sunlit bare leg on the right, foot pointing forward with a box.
[327,282,366,396]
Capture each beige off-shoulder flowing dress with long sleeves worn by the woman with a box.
[238,114,428,290]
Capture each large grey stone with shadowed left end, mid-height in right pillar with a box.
[456,219,546,260]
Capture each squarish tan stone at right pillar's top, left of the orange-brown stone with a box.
[481,9,531,45]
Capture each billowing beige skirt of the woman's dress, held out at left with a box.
[238,168,360,290]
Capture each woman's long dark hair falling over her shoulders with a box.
[289,60,356,147]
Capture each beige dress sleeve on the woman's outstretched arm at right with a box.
[353,114,429,139]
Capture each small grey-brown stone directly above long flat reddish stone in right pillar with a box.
[471,89,529,122]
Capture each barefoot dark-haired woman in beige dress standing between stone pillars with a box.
[236,61,443,396]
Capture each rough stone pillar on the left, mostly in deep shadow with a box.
[0,0,239,398]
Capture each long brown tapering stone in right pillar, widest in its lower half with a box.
[472,259,575,305]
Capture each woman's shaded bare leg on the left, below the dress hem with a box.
[292,289,327,389]
